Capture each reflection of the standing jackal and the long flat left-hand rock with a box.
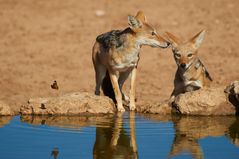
[21,112,138,159]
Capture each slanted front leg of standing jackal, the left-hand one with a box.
[109,71,125,112]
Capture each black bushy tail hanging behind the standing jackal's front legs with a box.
[101,71,116,103]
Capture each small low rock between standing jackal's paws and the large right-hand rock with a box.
[136,101,172,115]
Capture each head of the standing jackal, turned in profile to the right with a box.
[128,11,169,48]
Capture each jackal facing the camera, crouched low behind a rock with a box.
[166,30,212,100]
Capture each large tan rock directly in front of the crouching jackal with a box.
[172,87,236,115]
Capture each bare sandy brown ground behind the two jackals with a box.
[0,0,239,110]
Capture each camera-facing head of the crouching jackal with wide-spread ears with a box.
[166,30,205,70]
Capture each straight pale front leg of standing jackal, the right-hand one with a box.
[129,67,137,110]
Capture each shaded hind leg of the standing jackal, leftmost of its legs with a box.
[95,64,106,95]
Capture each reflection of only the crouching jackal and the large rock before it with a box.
[169,117,236,159]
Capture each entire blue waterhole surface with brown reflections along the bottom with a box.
[0,113,239,159]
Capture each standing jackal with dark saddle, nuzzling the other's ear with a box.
[92,11,169,112]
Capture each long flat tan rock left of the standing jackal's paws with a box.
[20,92,116,115]
